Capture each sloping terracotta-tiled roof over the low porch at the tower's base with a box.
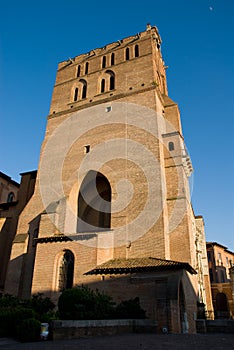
[85,257,196,275]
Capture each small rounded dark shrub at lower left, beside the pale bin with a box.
[17,318,41,342]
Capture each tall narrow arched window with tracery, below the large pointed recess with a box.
[59,250,74,292]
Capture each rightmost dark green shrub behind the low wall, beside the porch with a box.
[115,298,145,319]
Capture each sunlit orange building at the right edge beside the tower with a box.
[206,242,234,318]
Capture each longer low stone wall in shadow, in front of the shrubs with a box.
[50,319,157,340]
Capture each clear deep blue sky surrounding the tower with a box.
[0,0,234,251]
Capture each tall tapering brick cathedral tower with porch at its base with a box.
[4,25,212,333]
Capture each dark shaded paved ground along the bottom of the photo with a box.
[0,333,234,350]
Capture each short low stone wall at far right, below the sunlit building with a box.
[196,319,234,333]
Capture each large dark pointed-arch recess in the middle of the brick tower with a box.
[77,170,111,232]
